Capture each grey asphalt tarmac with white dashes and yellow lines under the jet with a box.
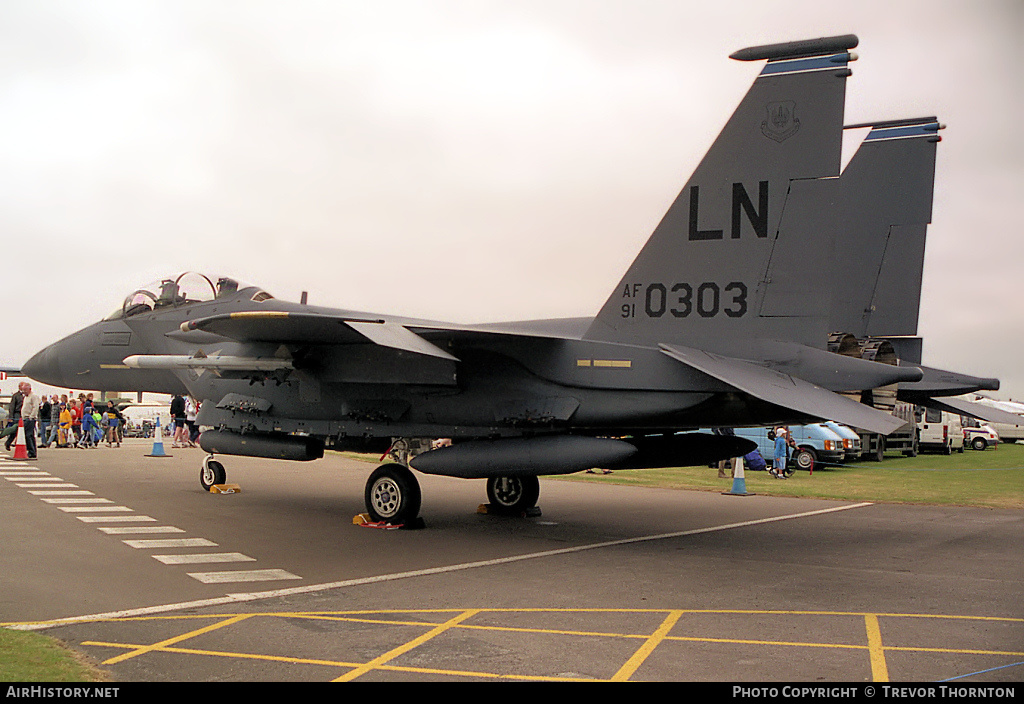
[0,440,1024,686]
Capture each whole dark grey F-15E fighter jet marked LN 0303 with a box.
[24,35,998,523]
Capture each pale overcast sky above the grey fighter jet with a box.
[0,0,1024,398]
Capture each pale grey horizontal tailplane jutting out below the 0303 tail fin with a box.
[658,344,906,435]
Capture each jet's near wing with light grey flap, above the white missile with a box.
[181,310,459,361]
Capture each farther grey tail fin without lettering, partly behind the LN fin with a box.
[828,117,942,338]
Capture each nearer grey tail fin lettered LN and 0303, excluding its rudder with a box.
[584,35,857,353]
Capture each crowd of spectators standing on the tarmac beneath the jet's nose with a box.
[0,382,199,457]
